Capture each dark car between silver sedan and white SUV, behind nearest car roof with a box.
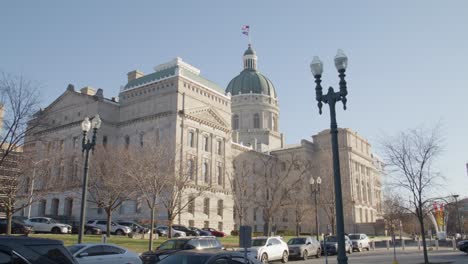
[141,236,223,264]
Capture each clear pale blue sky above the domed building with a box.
[0,0,468,196]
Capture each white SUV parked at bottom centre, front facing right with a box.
[247,236,289,263]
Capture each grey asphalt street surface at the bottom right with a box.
[290,249,468,264]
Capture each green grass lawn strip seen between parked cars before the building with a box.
[25,234,291,253]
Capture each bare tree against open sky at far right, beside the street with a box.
[382,127,443,264]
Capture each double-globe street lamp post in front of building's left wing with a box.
[78,115,101,244]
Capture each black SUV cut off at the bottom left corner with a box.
[0,236,78,264]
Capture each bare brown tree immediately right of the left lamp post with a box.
[89,146,135,237]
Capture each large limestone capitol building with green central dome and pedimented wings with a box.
[22,45,382,233]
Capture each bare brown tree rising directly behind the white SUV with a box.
[253,152,309,235]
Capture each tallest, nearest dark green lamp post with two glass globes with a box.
[310,50,348,264]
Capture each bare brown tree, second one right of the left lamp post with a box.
[126,143,175,251]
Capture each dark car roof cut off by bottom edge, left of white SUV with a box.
[159,250,261,264]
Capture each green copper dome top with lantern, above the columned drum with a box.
[226,44,276,98]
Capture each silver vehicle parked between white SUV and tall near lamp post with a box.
[288,236,322,260]
